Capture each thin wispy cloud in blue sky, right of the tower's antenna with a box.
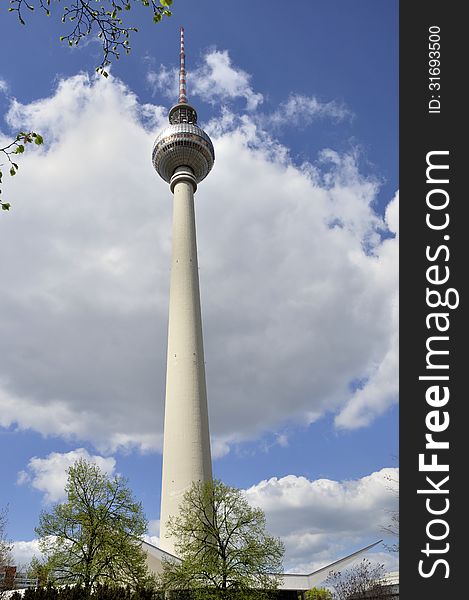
[262,94,352,127]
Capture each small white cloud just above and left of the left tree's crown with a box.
[17,448,116,504]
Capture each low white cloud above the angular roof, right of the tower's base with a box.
[246,468,398,573]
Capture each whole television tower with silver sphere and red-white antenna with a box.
[152,27,215,554]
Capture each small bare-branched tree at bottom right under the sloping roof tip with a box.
[326,558,387,600]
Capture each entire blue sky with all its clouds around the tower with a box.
[0,0,398,570]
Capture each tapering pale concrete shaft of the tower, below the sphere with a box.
[160,167,212,554]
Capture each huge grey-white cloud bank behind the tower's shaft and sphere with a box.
[0,70,397,456]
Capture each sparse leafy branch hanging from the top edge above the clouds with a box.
[8,0,173,77]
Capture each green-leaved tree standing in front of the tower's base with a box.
[158,481,284,599]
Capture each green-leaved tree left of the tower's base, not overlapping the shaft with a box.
[36,459,149,594]
